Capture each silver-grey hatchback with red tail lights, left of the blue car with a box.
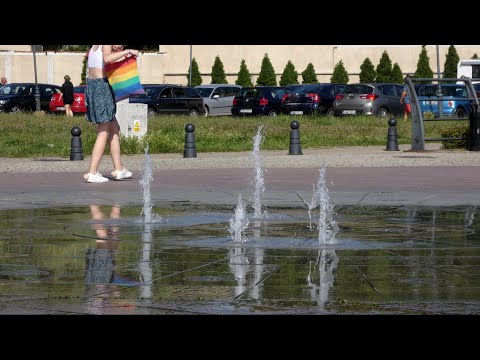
[333,83,405,117]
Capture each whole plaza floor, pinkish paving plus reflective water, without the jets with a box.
[0,148,480,314]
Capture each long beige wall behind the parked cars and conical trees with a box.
[0,45,480,85]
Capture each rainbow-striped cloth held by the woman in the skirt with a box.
[105,56,145,102]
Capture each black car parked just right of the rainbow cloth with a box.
[130,84,206,116]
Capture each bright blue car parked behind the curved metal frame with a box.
[418,84,471,118]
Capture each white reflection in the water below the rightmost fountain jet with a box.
[307,249,338,308]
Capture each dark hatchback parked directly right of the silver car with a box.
[232,86,288,116]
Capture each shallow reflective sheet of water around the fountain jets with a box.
[0,204,480,314]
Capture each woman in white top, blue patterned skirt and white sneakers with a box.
[83,45,138,183]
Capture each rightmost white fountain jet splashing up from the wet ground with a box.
[308,165,339,245]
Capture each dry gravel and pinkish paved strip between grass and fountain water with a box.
[0,144,480,209]
